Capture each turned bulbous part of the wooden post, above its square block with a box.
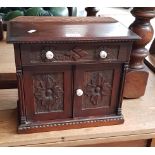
[129,8,155,69]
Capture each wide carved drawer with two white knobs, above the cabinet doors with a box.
[20,43,130,65]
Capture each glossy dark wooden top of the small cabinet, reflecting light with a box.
[7,16,140,43]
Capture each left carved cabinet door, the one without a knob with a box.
[23,66,72,121]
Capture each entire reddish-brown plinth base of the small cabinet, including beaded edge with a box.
[18,115,124,133]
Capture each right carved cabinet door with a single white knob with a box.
[73,63,122,117]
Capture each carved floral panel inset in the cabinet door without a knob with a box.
[33,73,64,113]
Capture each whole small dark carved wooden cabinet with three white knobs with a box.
[7,17,139,133]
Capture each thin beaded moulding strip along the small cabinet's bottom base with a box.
[18,115,124,130]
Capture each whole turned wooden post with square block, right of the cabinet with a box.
[124,7,155,98]
